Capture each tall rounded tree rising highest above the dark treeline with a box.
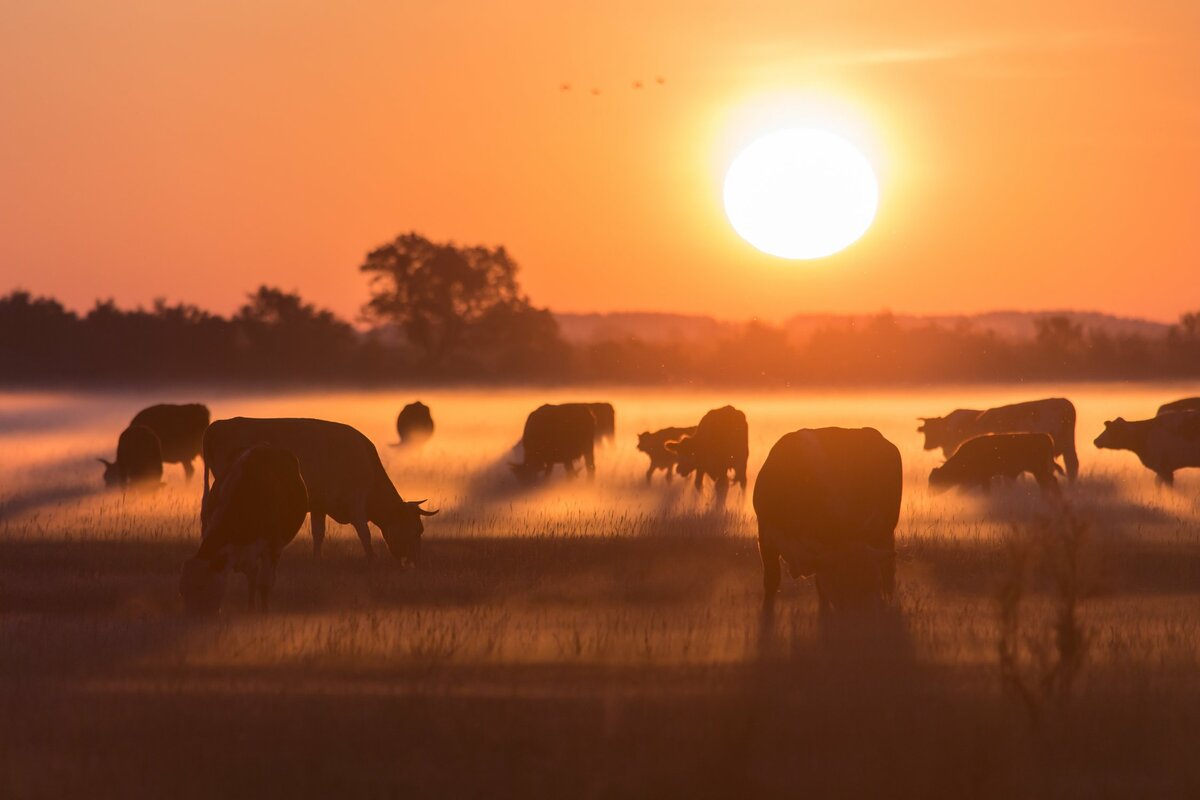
[360,233,563,371]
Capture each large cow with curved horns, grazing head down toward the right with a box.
[200,416,437,564]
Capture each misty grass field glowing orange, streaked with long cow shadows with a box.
[0,385,1200,798]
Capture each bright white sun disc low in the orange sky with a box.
[725,128,880,259]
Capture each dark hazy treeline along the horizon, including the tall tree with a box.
[0,234,1200,387]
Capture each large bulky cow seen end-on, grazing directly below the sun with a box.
[754,428,902,613]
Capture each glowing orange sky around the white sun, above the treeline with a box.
[0,0,1200,319]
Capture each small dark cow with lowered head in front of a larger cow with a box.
[929,433,1062,495]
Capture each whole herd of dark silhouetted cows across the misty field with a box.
[91,397,1200,614]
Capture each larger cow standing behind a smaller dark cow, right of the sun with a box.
[917,397,1079,481]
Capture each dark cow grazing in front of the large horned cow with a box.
[179,445,308,614]
